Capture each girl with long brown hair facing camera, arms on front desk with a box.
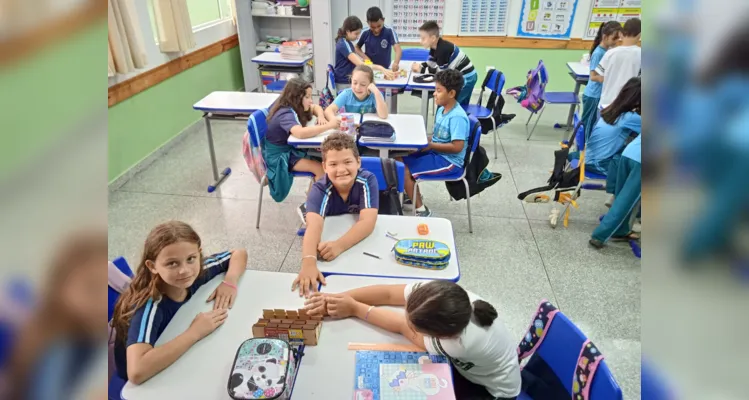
[112,221,247,384]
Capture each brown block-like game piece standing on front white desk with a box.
[252,309,322,346]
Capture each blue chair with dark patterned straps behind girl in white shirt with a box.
[518,311,623,400]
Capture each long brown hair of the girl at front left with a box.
[112,221,203,343]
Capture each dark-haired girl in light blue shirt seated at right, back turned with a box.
[585,78,642,175]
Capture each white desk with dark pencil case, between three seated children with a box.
[289,114,428,158]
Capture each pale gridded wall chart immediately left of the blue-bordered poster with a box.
[458,0,508,36]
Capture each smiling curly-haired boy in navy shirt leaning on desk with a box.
[291,132,380,296]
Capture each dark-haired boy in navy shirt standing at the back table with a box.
[356,7,403,72]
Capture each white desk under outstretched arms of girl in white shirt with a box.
[292,275,430,400]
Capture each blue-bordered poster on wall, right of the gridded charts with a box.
[517,0,577,39]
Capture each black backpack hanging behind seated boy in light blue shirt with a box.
[445,119,502,200]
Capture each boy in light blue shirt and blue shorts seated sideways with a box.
[403,69,470,217]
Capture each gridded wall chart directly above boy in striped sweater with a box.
[392,0,445,42]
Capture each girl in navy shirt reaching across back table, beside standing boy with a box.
[333,15,395,85]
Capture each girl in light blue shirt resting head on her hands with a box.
[325,64,388,120]
